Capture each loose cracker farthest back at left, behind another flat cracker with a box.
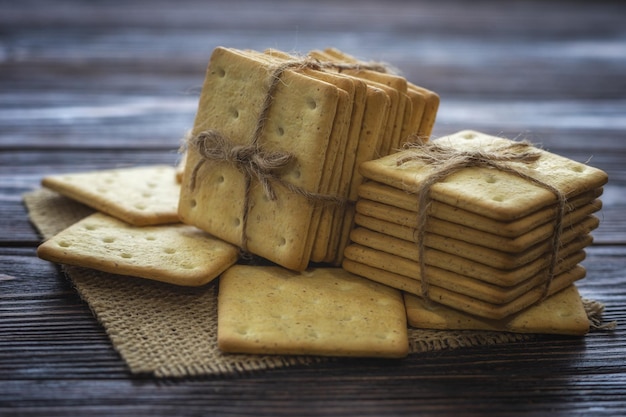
[41,165,180,226]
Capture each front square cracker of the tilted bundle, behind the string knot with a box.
[179,48,338,270]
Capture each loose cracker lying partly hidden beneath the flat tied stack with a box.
[404,285,589,336]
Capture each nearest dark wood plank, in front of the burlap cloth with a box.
[0,247,626,415]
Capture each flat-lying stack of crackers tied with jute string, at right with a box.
[343,131,607,319]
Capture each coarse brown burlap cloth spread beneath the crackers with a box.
[24,188,603,378]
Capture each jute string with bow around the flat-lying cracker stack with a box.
[397,141,567,301]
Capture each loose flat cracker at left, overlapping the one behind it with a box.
[37,213,238,286]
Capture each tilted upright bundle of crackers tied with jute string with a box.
[179,48,439,271]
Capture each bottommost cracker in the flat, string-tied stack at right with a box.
[343,258,586,319]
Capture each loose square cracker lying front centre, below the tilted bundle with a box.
[217,265,408,358]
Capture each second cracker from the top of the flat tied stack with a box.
[358,181,603,237]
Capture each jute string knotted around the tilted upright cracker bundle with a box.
[186,57,385,253]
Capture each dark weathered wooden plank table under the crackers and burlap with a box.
[0,0,626,416]
